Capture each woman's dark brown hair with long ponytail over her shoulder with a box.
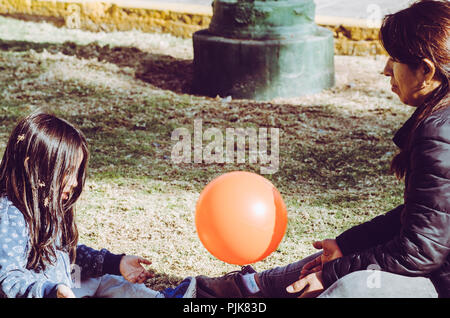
[380,0,450,179]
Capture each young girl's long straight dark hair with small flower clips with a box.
[0,112,89,271]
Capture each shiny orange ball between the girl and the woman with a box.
[195,171,287,265]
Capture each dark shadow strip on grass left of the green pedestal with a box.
[0,40,193,94]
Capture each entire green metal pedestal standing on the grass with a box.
[193,0,334,100]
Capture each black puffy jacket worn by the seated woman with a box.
[322,99,450,297]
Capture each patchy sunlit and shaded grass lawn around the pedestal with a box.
[0,17,412,289]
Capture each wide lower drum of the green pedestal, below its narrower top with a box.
[192,27,335,100]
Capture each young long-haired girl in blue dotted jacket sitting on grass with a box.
[0,113,195,298]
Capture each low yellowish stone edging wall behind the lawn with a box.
[0,0,385,56]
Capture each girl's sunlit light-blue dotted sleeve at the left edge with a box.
[0,199,56,298]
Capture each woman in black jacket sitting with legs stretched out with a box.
[197,0,450,297]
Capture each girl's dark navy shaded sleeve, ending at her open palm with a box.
[75,244,124,279]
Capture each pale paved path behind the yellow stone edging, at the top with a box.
[144,0,414,19]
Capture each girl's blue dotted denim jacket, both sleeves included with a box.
[0,196,123,298]
